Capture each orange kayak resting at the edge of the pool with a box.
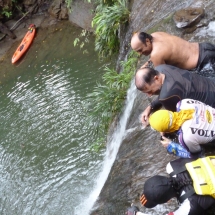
[12,24,36,63]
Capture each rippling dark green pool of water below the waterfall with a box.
[0,22,111,215]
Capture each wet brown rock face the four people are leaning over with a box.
[91,0,215,215]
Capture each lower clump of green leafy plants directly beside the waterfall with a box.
[87,51,138,149]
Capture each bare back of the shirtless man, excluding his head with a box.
[150,32,199,70]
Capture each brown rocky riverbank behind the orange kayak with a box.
[0,0,94,62]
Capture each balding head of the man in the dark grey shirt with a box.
[135,67,163,96]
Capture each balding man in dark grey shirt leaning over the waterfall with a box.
[135,64,215,125]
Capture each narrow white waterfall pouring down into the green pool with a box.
[75,80,136,215]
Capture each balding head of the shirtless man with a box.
[131,32,152,56]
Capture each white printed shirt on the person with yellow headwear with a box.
[177,99,215,152]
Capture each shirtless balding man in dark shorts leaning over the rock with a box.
[131,32,215,70]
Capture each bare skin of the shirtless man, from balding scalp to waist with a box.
[131,32,199,70]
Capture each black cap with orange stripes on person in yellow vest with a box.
[140,175,177,208]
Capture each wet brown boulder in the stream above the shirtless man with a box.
[173,7,205,28]
